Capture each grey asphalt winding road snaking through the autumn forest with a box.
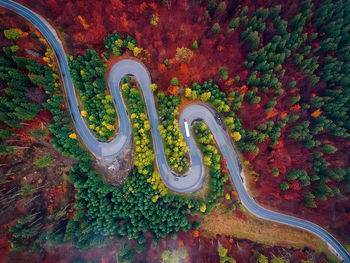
[0,0,350,263]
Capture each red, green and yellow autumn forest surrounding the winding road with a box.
[0,0,350,263]
